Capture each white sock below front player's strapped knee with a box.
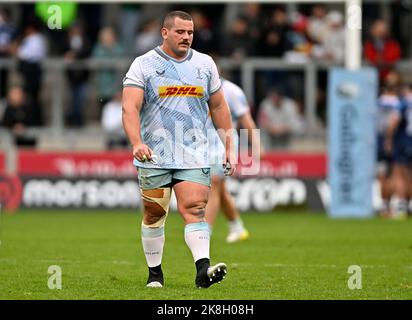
[142,225,165,268]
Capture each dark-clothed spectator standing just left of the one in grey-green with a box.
[64,24,91,127]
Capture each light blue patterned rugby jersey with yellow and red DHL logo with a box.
[123,47,221,169]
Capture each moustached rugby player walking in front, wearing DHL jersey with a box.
[123,11,236,288]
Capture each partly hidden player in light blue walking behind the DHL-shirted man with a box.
[206,79,263,243]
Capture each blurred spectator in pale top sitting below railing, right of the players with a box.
[258,90,305,149]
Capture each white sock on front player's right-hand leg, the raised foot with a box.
[185,222,210,262]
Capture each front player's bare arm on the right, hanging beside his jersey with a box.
[209,89,236,175]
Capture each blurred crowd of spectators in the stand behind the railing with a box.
[0,3,410,148]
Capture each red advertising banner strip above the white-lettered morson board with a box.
[17,150,327,178]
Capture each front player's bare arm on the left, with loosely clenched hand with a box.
[122,87,152,161]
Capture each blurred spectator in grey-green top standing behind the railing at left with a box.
[92,27,123,110]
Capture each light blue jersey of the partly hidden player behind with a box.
[207,79,250,164]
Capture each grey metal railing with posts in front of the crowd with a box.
[0,58,338,134]
